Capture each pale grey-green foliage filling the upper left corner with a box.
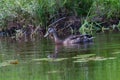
[0,0,36,27]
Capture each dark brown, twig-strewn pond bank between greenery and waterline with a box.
[0,16,120,38]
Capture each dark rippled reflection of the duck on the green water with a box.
[47,42,93,58]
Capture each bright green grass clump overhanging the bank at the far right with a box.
[79,0,120,34]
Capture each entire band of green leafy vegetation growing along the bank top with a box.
[0,0,120,34]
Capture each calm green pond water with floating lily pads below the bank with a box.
[0,33,120,80]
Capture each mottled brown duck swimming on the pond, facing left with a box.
[44,27,94,45]
